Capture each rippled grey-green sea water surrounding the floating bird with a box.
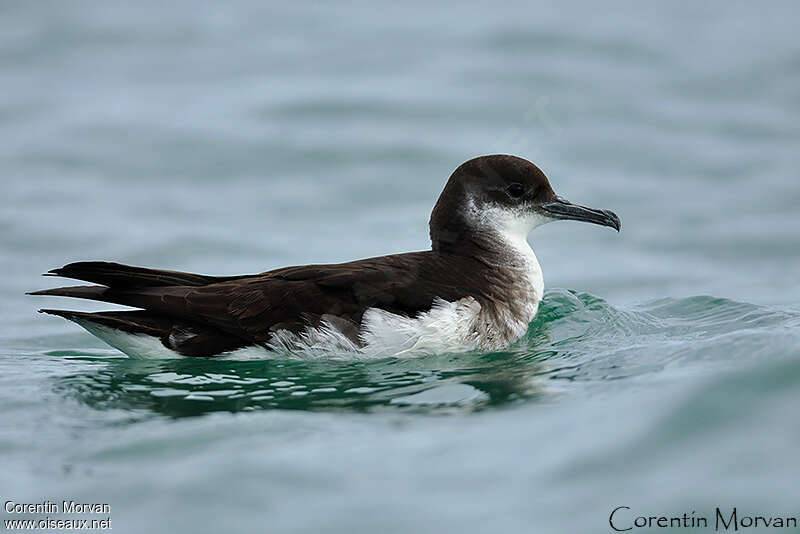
[0,1,800,532]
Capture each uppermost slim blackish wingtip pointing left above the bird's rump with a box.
[45,261,242,296]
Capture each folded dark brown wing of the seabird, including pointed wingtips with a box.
[29,251,482,343]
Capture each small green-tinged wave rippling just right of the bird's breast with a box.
[514,289,800,380]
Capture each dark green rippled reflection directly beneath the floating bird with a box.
[50,353,542,417]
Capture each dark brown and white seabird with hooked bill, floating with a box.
[30,155,620,358]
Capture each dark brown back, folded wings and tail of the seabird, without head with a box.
[32,251,508,356]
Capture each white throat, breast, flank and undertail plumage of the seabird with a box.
[69,202,553,360]
